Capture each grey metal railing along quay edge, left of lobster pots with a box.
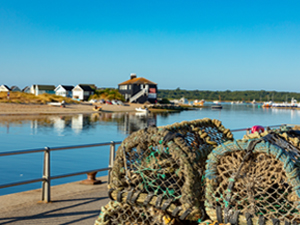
[0,141,122,202]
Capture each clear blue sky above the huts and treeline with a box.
[0,0,300,92]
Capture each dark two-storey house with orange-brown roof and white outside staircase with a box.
[118,73,157,103]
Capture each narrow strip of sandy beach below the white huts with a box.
[0,103,143,116]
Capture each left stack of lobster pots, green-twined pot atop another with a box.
[95,119,233,225]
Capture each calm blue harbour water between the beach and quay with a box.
[0,104,300,195]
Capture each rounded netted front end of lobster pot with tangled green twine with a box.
[109,127,203,220]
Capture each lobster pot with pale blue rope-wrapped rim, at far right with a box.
[205,138,300,224]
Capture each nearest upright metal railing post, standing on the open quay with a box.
[42,147,51,203]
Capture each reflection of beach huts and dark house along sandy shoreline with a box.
[0,113,157,136]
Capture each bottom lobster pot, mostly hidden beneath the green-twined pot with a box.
[95,201,178,225]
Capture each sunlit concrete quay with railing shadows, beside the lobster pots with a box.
[0,176,109,225]
